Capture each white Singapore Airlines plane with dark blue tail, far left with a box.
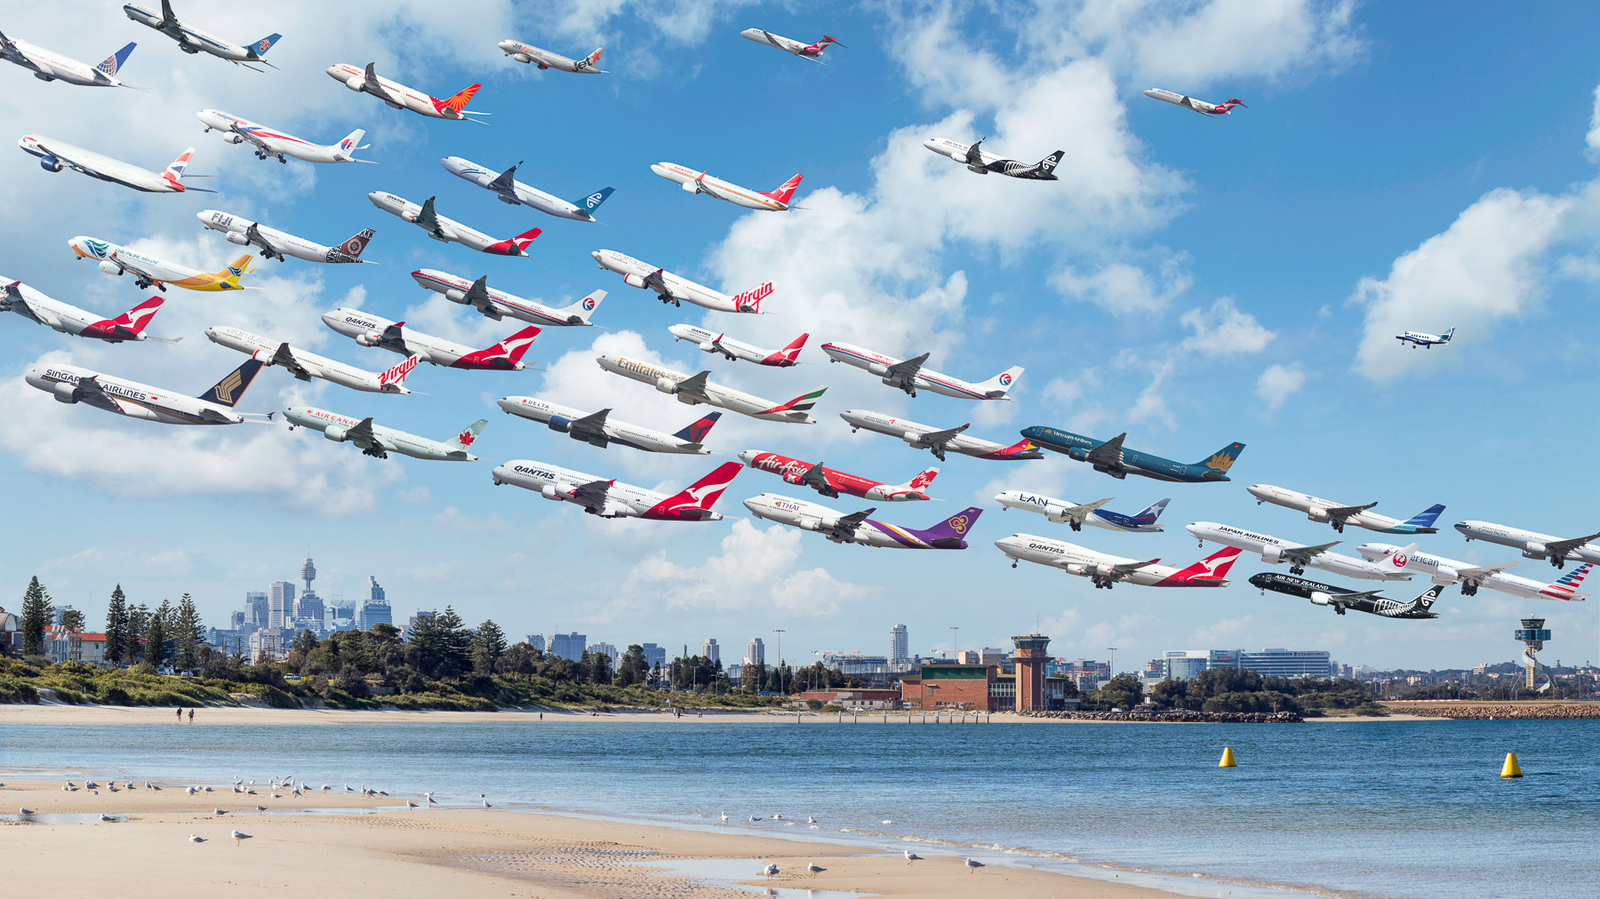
[24,358,272,424]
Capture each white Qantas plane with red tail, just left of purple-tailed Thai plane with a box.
[494,459,742,521]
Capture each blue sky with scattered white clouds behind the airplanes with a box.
[0,0,1600,667]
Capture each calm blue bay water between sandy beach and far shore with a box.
[0,710,1600,899]
